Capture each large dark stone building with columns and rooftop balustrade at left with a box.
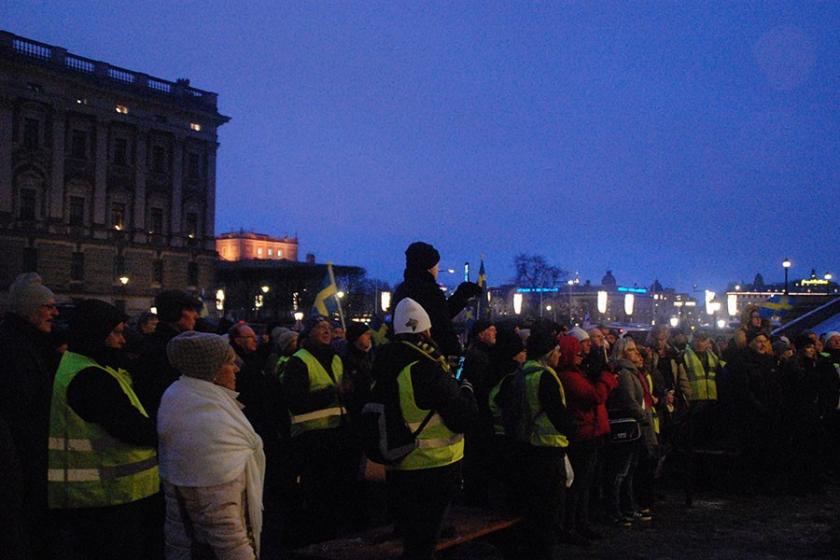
[0,31,229,313]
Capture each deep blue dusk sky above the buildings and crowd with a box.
[0,0,840,290]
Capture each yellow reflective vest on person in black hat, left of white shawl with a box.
[47,352,160,509]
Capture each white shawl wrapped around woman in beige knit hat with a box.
[157,375,265,556]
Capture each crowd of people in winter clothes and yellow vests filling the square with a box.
[0,242,840,560]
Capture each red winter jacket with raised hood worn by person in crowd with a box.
[558,336,618,440]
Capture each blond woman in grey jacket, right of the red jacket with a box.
[606,337,656,527]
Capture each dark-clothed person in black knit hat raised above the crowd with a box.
[393,241,482,357]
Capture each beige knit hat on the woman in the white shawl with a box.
[166,331,236,381]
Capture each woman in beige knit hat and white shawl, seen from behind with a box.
[157,331,265,560]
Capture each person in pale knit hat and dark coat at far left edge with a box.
[0,272,60,560]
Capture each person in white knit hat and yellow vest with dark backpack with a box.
[373,298,478,560]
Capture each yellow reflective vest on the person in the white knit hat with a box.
[388,361,464,471]
